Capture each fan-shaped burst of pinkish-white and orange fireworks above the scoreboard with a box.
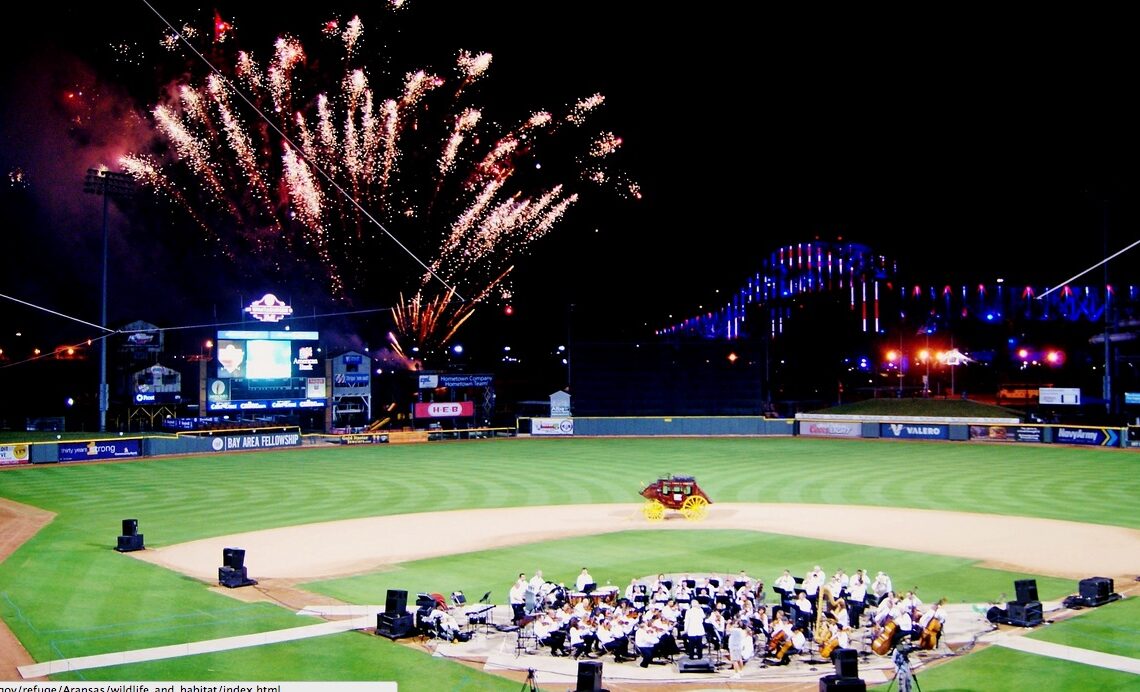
[122,6,638,357]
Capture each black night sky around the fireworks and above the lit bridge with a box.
[0,0,1140,369]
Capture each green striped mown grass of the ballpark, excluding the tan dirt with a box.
[0,438,1140,692]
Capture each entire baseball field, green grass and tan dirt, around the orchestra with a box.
[0,438,1140,692]
